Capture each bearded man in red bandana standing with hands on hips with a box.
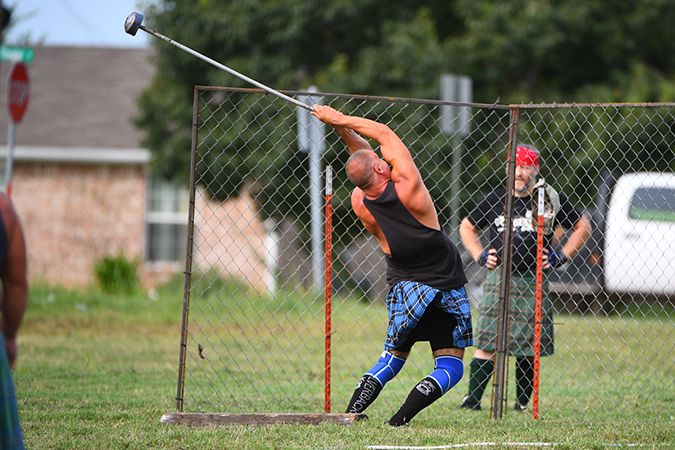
[459,145,591,411]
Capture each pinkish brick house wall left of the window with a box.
[12,159,146,287]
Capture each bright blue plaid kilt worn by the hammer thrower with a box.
[384,281,473,350]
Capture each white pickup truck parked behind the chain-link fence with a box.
[550,172,675,297]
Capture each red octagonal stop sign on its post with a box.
[5,63,30,197]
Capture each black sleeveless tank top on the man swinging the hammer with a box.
[363,181,467,291]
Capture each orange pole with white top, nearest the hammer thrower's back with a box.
[324,166,333,413]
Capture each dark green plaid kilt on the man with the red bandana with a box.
[475,268,554,357]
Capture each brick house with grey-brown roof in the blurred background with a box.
[0,46,286,291]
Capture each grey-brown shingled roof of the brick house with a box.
[0,46,154,153]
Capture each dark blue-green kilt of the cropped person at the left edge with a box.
[0,333,24,450]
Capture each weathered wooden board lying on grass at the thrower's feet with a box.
[160,413,367,427]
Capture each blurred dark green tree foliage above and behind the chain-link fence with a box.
[136,0,675,229]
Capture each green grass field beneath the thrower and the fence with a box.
[14,281,675,449]
